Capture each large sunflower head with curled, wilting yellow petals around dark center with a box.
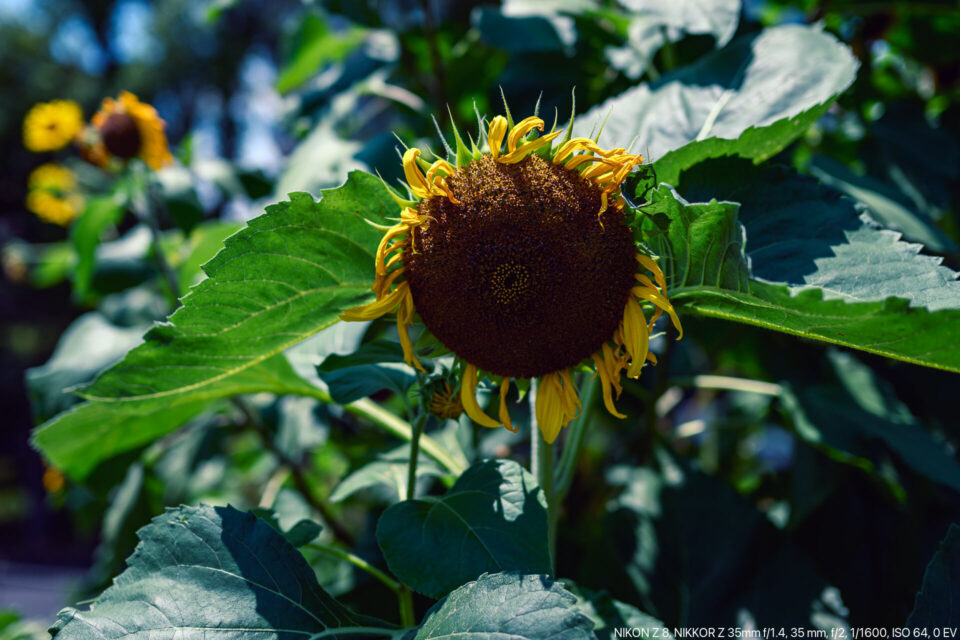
[341,109,682,443]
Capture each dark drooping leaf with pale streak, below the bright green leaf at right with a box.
[782,352,960,491]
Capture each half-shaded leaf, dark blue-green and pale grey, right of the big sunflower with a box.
[678,159,960,310]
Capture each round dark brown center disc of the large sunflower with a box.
[404,155,637,378]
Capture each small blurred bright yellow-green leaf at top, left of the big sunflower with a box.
[277,14,366,93]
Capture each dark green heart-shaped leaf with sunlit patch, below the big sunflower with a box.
[377,460,551,598]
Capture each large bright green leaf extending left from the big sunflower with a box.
[34,172,399,478]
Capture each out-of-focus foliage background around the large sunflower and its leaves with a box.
[0,0,960,638]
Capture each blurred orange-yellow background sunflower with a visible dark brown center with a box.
[86,91,173,170]
